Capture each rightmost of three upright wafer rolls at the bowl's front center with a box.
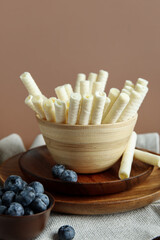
[91,92,106,125]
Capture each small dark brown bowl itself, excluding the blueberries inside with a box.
[0,192,55,240]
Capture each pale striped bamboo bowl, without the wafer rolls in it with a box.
[37,115,138,173]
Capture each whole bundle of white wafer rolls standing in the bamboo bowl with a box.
[20,70,148,125]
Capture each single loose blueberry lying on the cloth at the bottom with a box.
[58,225,75,240]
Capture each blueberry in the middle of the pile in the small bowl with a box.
[15,186,36,207]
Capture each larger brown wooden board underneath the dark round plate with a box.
[0,154,160,215]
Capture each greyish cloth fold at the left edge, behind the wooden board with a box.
[0,133,26,164]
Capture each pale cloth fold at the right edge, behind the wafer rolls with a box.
[136,133,159,153]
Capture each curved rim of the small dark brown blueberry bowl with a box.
[0,191,55,219]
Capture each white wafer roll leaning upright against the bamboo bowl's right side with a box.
[118,132,137,179]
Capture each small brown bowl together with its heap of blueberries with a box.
[0,175,55,240]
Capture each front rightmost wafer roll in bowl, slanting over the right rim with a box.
[118,90,142,122]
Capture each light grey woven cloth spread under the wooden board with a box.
[1,133,160,240]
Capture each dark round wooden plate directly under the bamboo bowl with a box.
[19,146,153,196]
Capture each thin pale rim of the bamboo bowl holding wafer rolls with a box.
[35,113,138,129]
